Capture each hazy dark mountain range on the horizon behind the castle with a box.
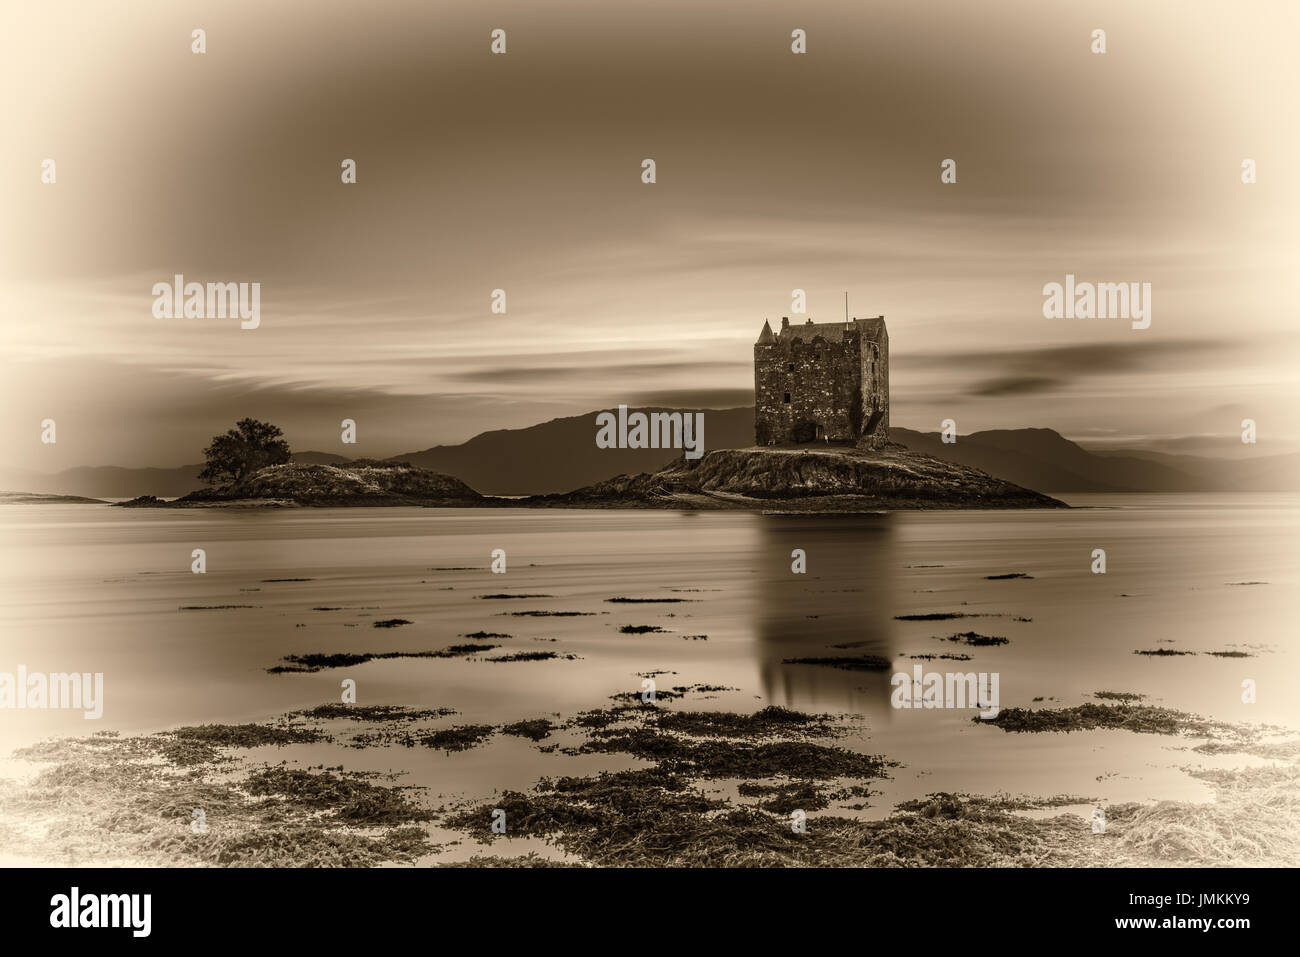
[0,407,1300,498]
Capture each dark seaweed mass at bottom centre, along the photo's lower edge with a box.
[442,767,1102,867]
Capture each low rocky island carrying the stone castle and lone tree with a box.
[109,316,1069,512]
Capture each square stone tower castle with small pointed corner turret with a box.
[754,316,889,449]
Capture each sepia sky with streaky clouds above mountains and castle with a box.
[0,0,1300,471]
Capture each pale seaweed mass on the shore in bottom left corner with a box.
[0,726,433,867]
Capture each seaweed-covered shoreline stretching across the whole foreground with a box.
[0,687,1300,867]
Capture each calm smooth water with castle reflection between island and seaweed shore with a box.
[0,495,1300,813]
